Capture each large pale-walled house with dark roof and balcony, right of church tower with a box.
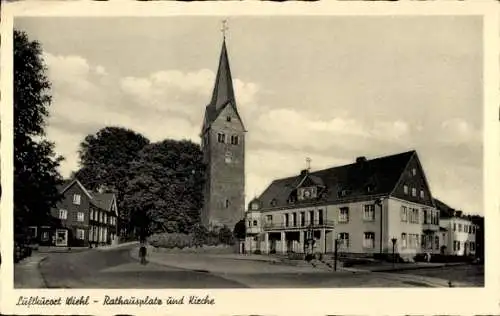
[245,150,440,256]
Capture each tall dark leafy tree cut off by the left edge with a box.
[14,30,63,232]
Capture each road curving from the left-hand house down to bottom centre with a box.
[40,247,245,289]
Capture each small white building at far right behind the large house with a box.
[434,199,482,256]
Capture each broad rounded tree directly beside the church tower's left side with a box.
[123,140,204,233]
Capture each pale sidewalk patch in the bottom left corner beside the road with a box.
[14,253,46,289]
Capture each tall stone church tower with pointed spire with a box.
[201,24,246,230]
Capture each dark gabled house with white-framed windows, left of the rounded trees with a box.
[30,179,118,247]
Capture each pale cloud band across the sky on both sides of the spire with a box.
[44,53,482,212]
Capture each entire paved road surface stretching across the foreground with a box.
[35,247,458,289]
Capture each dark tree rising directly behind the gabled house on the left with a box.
[73,127,149,235]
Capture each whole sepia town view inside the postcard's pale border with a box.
[2,2,498,316]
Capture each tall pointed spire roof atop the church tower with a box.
[202,40,245,132]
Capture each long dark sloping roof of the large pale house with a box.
[259,150,416,209]
